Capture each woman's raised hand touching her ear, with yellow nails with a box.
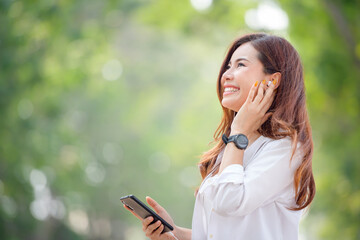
[230,80,275,136]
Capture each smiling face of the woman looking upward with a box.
[221,42,269,112]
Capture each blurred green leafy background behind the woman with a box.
[0,0,360,240]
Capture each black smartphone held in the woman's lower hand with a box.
[120,195,174,233]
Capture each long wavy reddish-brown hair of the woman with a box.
[199,33,315,210]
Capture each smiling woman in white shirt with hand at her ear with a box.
[125,33,315,240]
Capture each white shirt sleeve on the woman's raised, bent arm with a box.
[199,139,301,216]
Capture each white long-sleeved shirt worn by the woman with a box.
[192,136,302,240]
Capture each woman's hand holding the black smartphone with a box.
[124,197,176,240]
